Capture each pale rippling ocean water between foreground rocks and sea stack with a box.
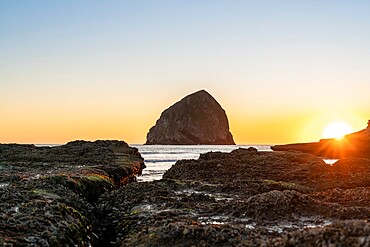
[131,145,272,182]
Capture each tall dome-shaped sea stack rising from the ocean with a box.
[146,90,235,145]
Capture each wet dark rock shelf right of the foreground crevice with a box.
[99,149,370,246]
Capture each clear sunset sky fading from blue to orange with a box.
[0,0,370,144]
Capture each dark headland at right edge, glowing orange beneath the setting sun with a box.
[271,120,370,159]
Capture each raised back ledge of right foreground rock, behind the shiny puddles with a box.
[163,148,370,192]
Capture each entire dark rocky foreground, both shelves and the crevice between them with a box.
[0,142,370,246]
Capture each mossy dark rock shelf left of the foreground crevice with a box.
[0,141,145,246]
